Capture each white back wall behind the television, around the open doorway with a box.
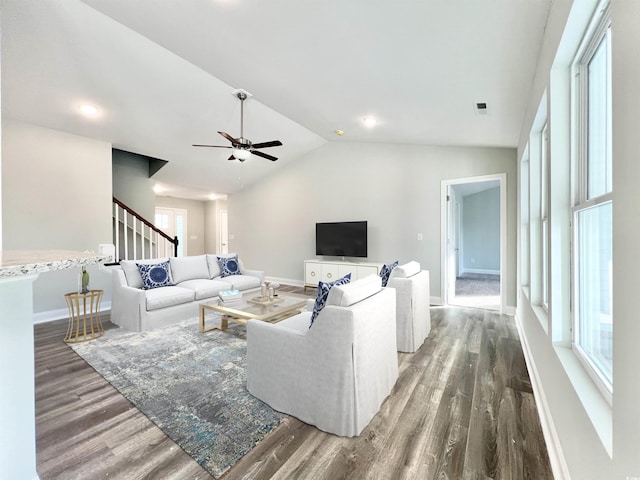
[228,142,516,306]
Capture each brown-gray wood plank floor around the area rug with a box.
[35,292,553,480]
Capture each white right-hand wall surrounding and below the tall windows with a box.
[517,0,640,480]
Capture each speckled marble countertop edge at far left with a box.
[0,250,109,279]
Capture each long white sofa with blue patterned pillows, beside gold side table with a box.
[111,254,264,332]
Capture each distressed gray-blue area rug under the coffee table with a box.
[72,320,285,477]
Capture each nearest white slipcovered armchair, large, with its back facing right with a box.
[247,275,398,437]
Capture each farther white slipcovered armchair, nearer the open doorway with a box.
[387,261,431,352]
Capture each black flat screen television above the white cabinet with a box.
[316,221,367,257]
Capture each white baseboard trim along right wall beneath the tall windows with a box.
[515,316,571,480]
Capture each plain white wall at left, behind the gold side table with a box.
[1,120,112,315]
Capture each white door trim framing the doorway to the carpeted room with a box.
[440,173,508,313]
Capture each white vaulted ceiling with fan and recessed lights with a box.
[1,0,551,199]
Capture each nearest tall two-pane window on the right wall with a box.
[573,2,613,393]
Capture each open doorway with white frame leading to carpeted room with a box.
[441,174,506,312]
